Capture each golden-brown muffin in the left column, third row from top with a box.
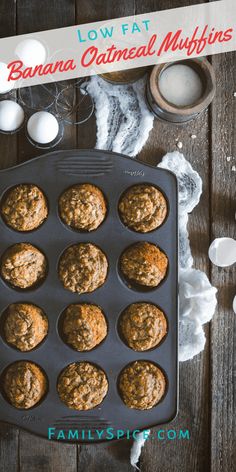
[3,303,48,352]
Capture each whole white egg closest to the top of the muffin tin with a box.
[27,111,59,144]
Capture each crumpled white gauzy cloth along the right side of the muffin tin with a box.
[158,151,217,362]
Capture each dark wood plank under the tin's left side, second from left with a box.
[14,0,77,472]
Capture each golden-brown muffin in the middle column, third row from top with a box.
[62,303,107,351]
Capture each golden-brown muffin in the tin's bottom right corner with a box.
[119,361,166,410]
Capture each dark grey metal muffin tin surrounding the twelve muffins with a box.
[0,150,178,443]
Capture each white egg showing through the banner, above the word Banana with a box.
[15,39,47,67]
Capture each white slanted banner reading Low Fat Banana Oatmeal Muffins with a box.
[0,0,236,88]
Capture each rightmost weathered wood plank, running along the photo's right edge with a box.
[211,48,236,472]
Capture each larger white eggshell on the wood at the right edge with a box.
[208,238,236,267]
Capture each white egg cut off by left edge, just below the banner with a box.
[0,100,25,132]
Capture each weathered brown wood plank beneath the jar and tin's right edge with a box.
[136,0,210,472]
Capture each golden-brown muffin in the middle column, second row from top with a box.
[59,243,108,293]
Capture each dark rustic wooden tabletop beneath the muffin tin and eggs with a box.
[0,0,236,472]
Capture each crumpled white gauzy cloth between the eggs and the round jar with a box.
[86,76,154,157]
